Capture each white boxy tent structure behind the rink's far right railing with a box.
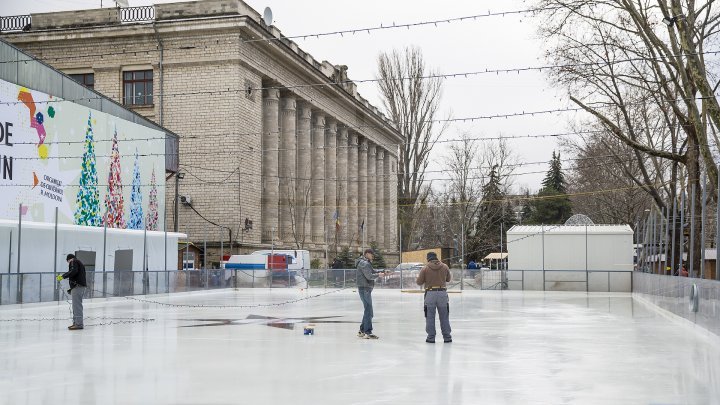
[507,225,633,292]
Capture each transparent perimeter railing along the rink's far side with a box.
[0,269,632,305]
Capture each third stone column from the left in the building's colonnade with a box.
[293,101,312,246]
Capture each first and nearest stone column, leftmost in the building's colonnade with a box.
[261,89,280,242]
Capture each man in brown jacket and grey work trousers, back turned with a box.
[417,252,452,343]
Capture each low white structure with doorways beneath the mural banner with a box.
[0,219,185,273]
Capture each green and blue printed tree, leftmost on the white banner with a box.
[75,112,102,226]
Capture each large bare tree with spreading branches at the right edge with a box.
[536,0,720,274]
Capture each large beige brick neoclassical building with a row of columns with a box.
[2,0,402,265]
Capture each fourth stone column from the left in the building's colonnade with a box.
[311,112,329,244]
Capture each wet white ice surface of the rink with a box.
[0,289,720,405]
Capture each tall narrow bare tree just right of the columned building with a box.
[378,47,447,249]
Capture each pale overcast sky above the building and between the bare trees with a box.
[2,0,573,191]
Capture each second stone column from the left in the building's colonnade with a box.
[278,95,297,244]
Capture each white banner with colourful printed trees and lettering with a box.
[0,80,165,230]
